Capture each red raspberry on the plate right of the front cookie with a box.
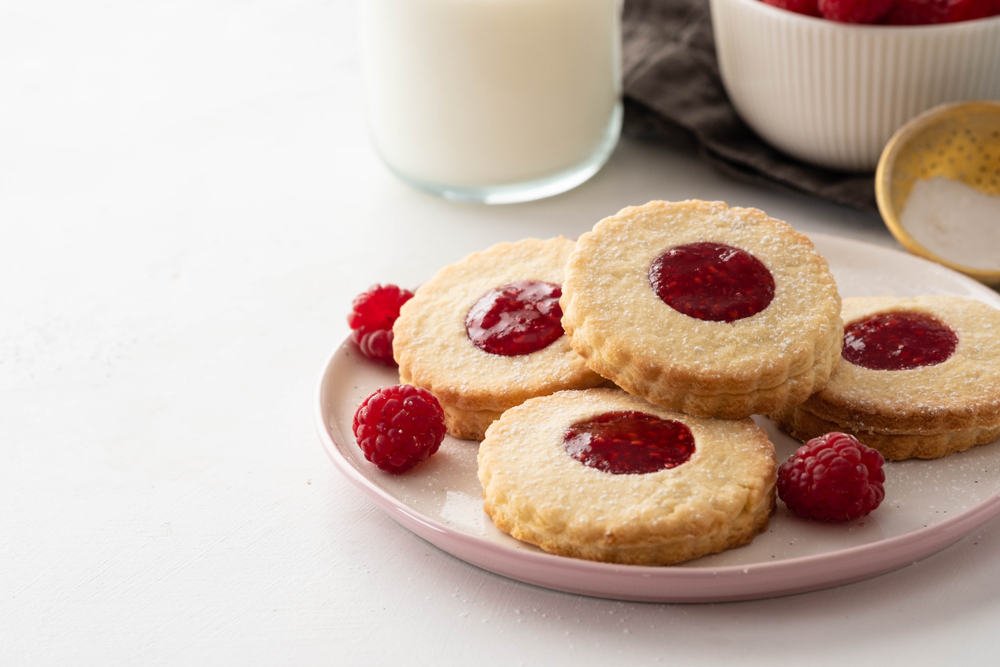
[778,433,885,521]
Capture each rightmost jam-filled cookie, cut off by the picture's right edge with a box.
[770,296,1000,460]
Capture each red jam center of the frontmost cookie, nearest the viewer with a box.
[563,411,694,475]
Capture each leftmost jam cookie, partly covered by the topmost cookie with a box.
[393,237,604,440]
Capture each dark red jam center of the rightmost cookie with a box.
[841,312,958,371]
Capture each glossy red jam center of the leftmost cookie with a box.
[465,280,563,357]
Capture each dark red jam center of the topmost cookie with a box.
[649,242,774,322]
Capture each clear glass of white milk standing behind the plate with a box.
[359,0,622,203]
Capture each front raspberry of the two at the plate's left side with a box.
[354,384,444,475]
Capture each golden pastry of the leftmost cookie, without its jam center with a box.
[393,237,604,440]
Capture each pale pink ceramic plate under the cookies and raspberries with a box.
[316,235,1000,602]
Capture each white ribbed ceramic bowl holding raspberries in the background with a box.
[711,0,1000,171]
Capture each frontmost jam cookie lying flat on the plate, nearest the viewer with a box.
[479,388,775,565]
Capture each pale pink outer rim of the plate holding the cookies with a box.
[314,233,1000,602]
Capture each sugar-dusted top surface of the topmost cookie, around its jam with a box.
[563,202,840,393]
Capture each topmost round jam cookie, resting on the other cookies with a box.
[561,201,843,419]
